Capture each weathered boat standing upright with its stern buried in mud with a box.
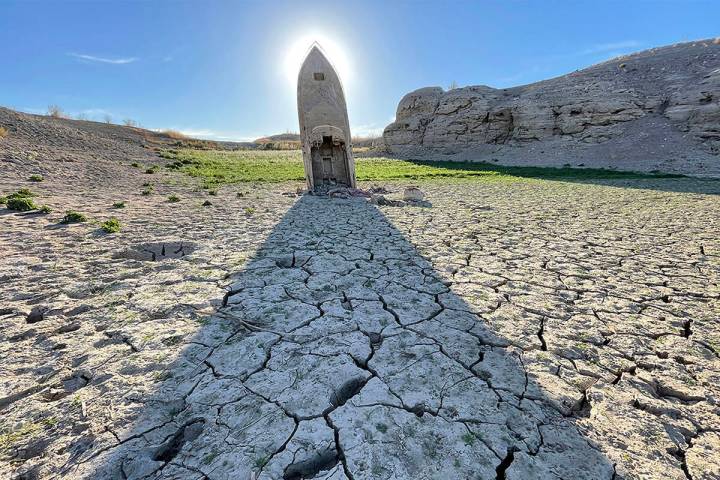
[297,45,355,190]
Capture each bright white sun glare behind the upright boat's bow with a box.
[283,33,353,90]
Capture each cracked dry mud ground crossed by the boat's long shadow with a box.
[0,172,720,480]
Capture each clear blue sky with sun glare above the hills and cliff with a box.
[0,0,720,140]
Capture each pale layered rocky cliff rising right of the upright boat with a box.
[383,39,720,176]
